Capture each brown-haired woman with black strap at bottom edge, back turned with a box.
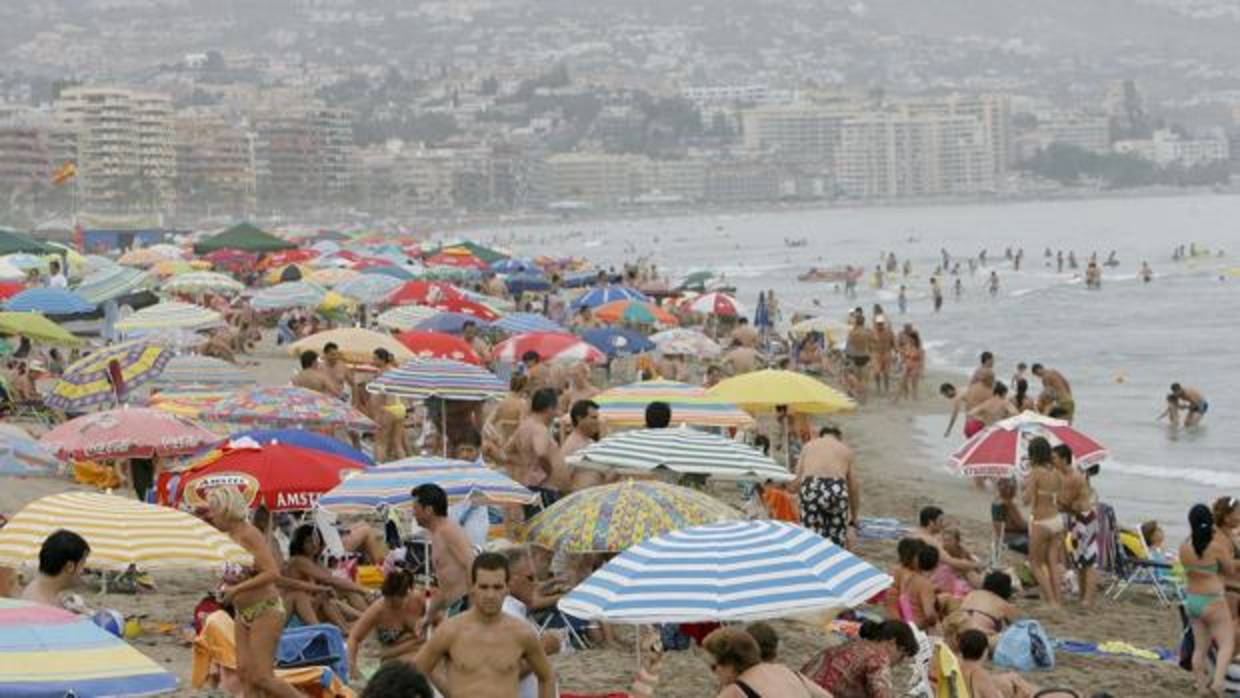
[702,627,831,698]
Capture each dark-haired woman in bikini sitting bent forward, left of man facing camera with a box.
[348,570,427,678]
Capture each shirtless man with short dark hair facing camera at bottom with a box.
[413,553,556,698]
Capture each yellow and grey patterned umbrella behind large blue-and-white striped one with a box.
[521,480,744,553]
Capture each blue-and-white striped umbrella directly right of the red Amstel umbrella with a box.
[319,456,537,513]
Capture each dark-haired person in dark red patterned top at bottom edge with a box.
[801,620,918,698]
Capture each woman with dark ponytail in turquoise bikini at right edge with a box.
[1179,505,1235,696]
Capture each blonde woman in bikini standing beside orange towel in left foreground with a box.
[200,486,303,698]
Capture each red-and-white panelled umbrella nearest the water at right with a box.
[947,410,1109,477]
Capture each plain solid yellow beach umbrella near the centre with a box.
[711,368,857,414]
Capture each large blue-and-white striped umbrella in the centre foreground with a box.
[559,521,892,624]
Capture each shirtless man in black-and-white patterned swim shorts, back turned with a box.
[792,425,861,546]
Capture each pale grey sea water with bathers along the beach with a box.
[498,195,1240,533]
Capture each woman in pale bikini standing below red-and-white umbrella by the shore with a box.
[1024,436,1064,606]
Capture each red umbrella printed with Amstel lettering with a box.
[157,438,362,511]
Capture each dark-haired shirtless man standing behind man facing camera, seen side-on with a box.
[412,484,474,630]
